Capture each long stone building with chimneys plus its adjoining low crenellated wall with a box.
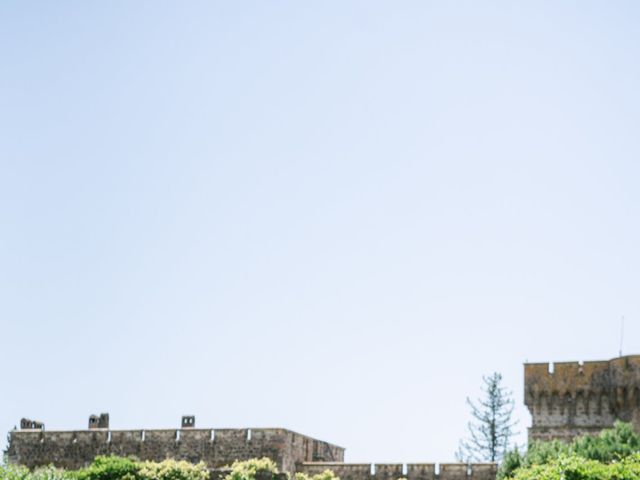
[8,414,496,480]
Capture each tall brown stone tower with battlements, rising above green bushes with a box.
[524,355,640,441]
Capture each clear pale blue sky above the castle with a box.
[0,0,640,462]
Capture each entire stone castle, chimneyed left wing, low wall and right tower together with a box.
[7,355,640,480]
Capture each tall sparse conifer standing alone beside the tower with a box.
[456,372,515,462]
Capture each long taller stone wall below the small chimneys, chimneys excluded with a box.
[8,428,344,471]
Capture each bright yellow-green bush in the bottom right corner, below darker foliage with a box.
[513,454,640,480]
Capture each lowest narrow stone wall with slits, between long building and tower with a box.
[298,462,497,480]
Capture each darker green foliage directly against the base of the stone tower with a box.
[498,422,640,480]
